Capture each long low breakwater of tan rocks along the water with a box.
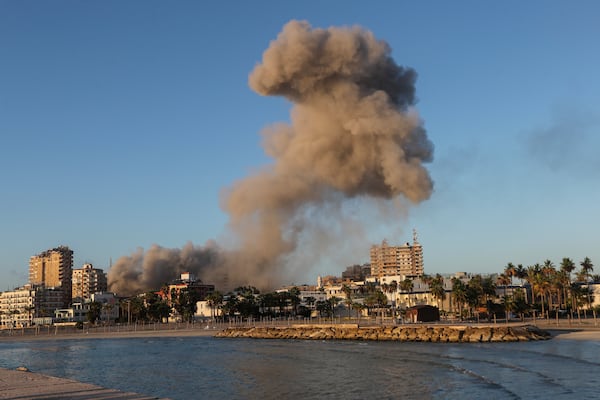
[215,324,551,343]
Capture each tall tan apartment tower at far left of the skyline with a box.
[29,246,73,307]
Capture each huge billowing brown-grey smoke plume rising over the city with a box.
[109,21,433,293]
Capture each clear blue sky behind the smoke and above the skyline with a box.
[0,0,600,290]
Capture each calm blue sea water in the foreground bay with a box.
[0,337,600,400]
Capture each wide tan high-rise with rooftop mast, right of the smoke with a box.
[371,231,423,278]
